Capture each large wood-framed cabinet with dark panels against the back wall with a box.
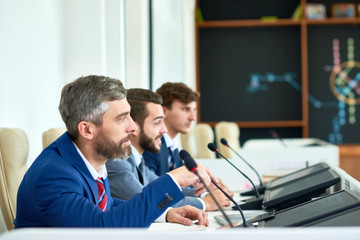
[195,0,360,144]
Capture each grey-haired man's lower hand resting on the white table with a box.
[166,205,209,227]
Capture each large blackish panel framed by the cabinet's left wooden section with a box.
[199,26,301,122]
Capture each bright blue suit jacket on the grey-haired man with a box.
[14,132,184,228]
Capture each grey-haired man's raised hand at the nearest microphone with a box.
[169,164,219,196]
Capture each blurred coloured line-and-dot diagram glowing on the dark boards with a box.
[247,38,360,144]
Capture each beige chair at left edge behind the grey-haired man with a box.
[0,128,29,230]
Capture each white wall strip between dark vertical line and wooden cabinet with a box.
[152,0,195,90]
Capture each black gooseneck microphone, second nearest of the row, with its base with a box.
[208,143,263,210]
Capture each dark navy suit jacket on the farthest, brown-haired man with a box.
[143,137,184,176]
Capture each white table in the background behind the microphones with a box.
[196,139,339,190]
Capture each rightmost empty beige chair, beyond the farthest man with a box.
[215,122,240,158]
